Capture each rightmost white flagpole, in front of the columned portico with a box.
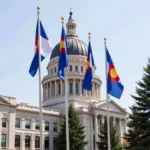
[104,38,111,150]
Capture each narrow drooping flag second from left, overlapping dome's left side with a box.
[58,26,69,80]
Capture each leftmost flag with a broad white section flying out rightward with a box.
[29,21,53,77]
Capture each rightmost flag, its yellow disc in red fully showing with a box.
[106,47,124,99]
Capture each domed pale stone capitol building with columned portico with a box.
[0,12,127,150]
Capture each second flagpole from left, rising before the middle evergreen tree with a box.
[61,17,70,150]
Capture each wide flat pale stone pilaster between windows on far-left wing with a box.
[8,108,16,150]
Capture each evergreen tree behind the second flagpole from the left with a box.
[56,105,88,150]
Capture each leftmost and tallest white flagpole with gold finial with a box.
[37,7,43,150]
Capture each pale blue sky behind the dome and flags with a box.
[0,0,150,112]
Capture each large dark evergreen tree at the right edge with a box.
[125,59,150,150]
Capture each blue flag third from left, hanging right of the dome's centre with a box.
[82,41,95,91]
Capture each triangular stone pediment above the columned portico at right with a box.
[96,100,127,113]
